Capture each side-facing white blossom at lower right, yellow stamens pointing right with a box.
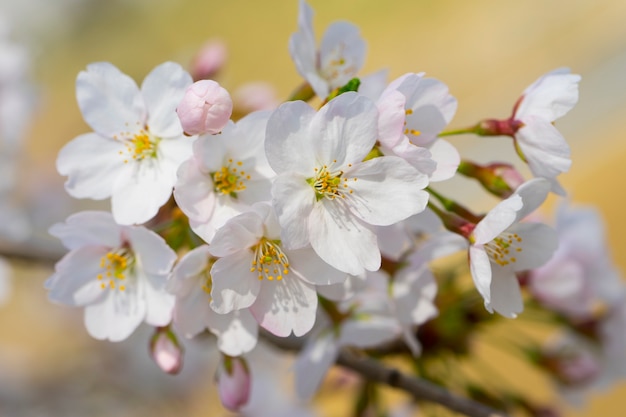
[468,178,558,318]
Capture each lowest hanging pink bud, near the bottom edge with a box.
[217,356,251,411]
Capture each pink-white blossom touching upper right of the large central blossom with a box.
[377,73,460,181]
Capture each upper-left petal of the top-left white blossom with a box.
[76,62,146,138]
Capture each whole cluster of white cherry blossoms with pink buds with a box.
[46,1,626,409]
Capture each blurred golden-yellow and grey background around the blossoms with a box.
[0,0,626,417]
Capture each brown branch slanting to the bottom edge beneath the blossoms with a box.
[262,331,508,417]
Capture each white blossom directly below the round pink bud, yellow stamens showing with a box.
[174,112,276,243]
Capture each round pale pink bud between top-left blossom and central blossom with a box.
[176,80,233,135]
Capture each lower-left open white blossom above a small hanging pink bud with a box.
[45,211,176,342]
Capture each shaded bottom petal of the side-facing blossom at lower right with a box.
[485,269,524,318]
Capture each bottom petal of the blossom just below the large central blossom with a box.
[250,275,317,337]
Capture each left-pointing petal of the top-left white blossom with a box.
[56,133,125,200]
